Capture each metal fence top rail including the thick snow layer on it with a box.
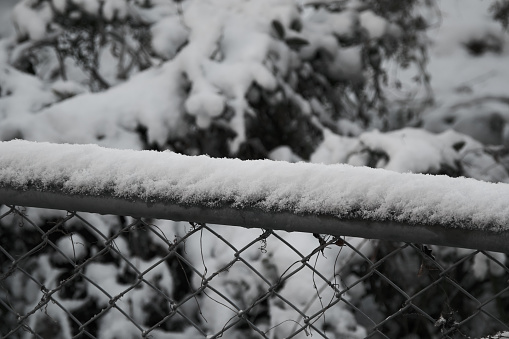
[0,140,509,251]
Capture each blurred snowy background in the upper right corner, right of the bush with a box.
[398,1,509,146]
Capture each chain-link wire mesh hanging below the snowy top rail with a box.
[0,206,509,339]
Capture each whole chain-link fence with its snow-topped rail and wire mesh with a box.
[0,141,509,338]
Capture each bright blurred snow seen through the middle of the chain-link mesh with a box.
[177,225,374,338]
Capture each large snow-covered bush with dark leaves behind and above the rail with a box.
[0,0,432,159]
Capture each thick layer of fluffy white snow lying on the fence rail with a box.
[0,140,509,231]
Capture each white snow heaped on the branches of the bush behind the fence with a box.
[0,0,410,154]
